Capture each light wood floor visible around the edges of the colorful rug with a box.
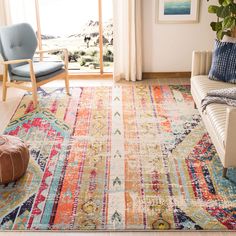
[0,79,233,236]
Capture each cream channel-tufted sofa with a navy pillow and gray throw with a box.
[191,51,236,177]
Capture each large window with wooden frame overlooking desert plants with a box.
[10,0,113,74]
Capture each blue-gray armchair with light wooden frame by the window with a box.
[0,23,69,107]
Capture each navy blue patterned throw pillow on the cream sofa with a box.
[209,40,236,84]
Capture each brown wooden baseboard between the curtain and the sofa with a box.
[143,71,191,79]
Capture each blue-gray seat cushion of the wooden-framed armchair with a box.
[11,62,64,78]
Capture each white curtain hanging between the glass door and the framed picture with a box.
[113,0,142,81]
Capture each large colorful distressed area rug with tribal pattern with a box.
[0,86,236,230]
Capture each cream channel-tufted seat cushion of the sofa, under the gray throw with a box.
[191,75,236,145]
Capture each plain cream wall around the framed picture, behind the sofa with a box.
[142,0,216,72]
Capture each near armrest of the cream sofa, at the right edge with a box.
[224,107,236,167]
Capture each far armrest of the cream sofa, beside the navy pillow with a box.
[191,51,212,77]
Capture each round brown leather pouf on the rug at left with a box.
[0,135,29,184]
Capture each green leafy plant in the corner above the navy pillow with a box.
[207,0,236,40]
